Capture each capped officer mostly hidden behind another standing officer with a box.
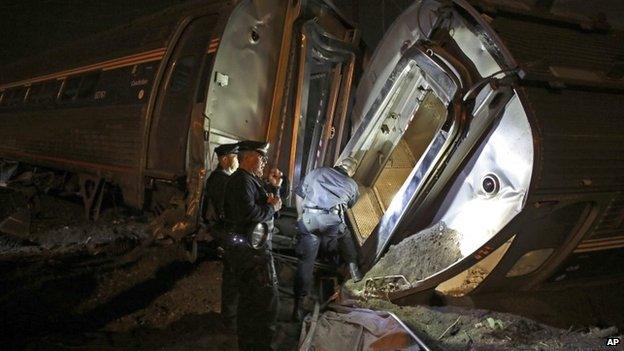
[203,144,238,226]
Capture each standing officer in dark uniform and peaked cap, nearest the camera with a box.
[223,140,282,350]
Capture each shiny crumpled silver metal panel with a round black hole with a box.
[434,97,533,256]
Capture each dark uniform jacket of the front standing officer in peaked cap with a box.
[223,168,275,234]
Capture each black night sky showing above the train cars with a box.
[0,0,624,70]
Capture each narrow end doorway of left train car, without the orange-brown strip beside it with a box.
[281,2,359,192]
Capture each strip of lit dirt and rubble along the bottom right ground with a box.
[360,300,622,351]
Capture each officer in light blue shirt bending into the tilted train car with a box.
[293,157,362,320]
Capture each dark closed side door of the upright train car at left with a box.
[146,16,217,179]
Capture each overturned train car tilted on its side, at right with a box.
[341,0,624,303]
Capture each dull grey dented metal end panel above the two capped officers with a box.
[204,0,285,140]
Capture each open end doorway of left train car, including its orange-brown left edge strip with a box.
[267,0,359,195]
